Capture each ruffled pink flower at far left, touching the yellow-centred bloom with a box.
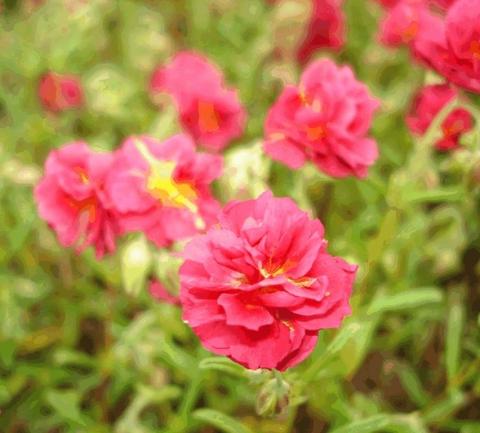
[35,142,118,257]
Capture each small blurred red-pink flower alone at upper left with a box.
[38,72,83,112]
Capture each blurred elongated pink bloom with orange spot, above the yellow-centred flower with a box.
[150,52,246,151]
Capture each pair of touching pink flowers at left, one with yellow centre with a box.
[35,135,222,257]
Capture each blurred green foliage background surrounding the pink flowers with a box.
[0,0,480,433]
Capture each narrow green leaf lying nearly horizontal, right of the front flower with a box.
[368,287,443,314]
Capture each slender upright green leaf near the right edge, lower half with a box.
[445,296,465,382]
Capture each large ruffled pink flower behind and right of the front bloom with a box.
[265,59,379,177]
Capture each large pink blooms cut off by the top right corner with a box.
[380,0,480,93]
